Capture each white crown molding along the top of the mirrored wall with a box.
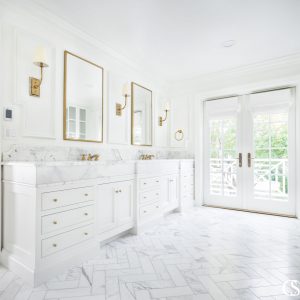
[0,0,165,84]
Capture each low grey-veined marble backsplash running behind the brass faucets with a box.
[2,144,194,161]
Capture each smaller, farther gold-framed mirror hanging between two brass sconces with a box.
[131,82,152,146]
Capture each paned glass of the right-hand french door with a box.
[253,112,288,201]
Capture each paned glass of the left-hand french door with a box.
[209,117,237,197]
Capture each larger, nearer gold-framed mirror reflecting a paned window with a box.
[64,51,103,143]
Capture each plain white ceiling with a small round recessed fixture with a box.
[26,0,300,81]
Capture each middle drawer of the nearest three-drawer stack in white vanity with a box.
[42,205,94,234]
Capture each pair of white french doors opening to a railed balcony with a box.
[203,89,295,215]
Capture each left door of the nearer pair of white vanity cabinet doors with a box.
[96,184,117,234]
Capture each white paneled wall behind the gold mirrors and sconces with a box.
[0,0,188,150]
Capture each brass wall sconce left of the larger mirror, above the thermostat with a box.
[29,47,48,97]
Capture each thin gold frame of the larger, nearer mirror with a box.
[63,50,104,143]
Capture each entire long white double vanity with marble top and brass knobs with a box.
[0,159,194,286]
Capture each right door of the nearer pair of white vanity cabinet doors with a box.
[115,181,133,225]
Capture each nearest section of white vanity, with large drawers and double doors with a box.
[1,161,135,286]
